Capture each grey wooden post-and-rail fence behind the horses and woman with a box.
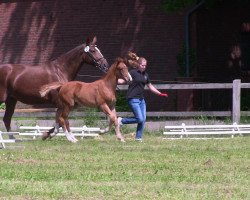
[0,79,250,123]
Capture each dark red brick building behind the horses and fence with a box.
[0,0,250,111]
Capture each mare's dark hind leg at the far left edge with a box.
[3,97,17,139]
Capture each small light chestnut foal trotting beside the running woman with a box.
[40,58,132,142]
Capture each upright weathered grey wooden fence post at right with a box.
[232,79,241,124]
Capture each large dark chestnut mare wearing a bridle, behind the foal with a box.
[0,37,108,138]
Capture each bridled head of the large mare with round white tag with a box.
[84,36,109,72]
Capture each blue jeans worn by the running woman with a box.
[121,99,146,139]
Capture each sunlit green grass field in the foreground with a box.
[0,133,250,200]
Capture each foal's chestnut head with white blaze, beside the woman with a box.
[114,58,132,82]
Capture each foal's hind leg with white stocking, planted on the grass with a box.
[58,105,78,143]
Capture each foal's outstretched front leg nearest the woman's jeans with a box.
[100,104,125,142]
